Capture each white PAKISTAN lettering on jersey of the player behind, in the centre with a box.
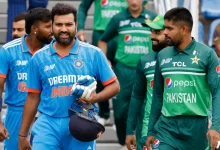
[125,46,149,54]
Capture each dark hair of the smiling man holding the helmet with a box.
[51,3,77,22]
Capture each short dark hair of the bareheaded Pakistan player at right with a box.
[164,7,193,32]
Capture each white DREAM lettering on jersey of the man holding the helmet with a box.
[48,75,83,86]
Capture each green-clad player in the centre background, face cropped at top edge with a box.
[98,0,156,145]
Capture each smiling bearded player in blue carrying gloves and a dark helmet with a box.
[19,3,119,150]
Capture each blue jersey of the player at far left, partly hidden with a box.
[0,35,32,107]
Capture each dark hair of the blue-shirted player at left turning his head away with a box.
[25,7,51,34]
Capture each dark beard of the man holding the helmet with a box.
[54,32,75,46]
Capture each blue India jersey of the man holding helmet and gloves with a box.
[27,38,116,117]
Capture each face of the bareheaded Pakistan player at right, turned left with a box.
[164,20,183,47]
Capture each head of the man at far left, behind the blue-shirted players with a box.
[12,12,27,39]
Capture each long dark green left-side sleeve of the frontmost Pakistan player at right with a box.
[147,58,164,136]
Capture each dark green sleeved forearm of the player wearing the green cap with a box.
[126,96,144,135]
